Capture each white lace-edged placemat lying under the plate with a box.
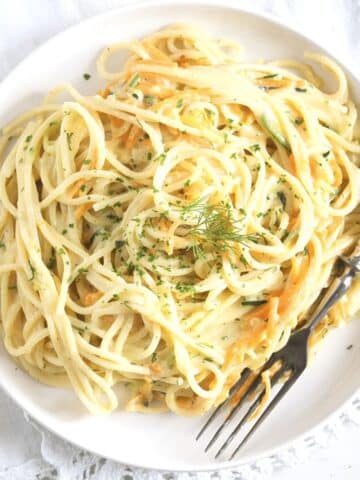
[0,0,360,480]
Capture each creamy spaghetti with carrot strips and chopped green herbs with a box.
[0,25,360,415]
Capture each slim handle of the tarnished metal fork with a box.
[305,266,358,332]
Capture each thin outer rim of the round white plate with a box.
[0,0,360,473]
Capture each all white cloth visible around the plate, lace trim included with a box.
[0,0,360,480]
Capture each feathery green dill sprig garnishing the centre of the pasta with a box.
[181,198,260,258]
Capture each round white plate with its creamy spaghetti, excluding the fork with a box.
[0,2,360,471]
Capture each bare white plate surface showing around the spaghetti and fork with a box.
[0,0,360,471]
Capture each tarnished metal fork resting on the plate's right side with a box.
[196,243,360,460]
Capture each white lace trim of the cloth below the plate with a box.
[0,396,354,480]
